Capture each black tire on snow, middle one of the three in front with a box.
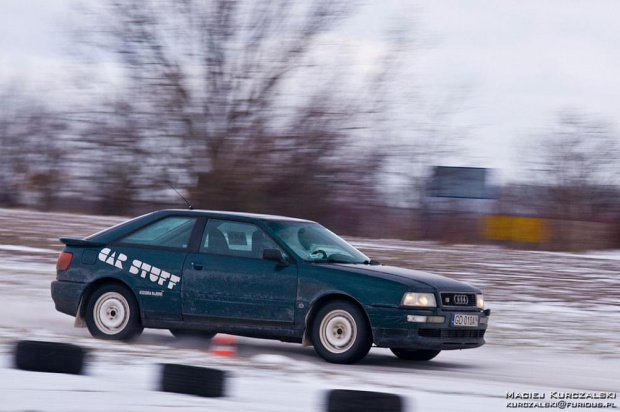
[161,363,226,398]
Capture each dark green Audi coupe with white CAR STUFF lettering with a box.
[52,210,490,363]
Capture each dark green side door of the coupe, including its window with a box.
[181,219,297,325]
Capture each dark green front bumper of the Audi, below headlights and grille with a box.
[369,308,491,350]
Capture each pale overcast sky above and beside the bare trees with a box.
[0,0,620,179]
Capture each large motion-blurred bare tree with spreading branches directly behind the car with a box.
[70,0,384,229]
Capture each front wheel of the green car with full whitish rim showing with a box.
[312,301,372,364]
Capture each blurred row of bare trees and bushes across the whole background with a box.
[0,0,620,245]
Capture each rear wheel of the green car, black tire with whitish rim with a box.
[84,284,144,340]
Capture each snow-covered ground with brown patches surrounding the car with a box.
[0,209,620,412]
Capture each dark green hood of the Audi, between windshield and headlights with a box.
[337,264,481,293]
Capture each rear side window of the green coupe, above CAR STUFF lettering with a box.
[121,216,196,249]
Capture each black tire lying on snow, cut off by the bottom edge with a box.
[327,389,403,412]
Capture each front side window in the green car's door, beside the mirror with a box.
[200,219,285,259]
